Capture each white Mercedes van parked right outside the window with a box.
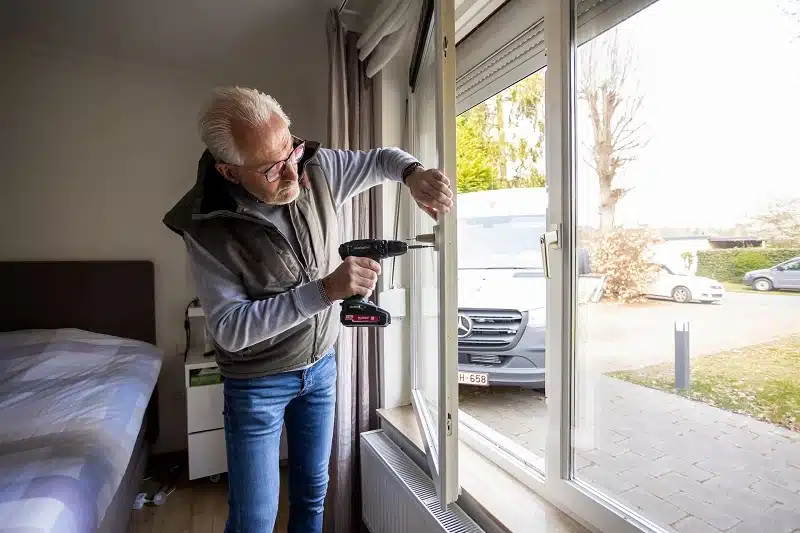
[457,188,547,388]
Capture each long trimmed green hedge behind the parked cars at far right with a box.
[697,248,800,283]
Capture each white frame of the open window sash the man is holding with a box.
[408,0,460,507]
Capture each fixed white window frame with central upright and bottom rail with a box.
[432,0,692,533]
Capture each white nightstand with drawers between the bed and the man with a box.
[183,349,288,480]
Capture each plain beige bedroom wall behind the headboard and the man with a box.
[0,38,327,452]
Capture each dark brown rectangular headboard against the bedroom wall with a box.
[0,261,156,344]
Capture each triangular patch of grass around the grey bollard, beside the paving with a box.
[609,335,800,431]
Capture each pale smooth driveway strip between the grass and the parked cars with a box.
[577,293,800,373]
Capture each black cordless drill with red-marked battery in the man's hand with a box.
[339,239,429,328]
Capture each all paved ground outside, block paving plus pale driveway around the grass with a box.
[459,293,800,533]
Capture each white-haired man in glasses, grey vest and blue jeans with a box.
[164,87,452,533]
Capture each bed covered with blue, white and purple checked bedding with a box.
[0,329,163,533]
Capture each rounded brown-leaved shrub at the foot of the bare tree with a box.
[593,229,661,302]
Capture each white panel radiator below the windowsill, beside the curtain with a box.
[361,430,484,533]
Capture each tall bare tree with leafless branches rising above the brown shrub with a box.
[578,28,647,233]
